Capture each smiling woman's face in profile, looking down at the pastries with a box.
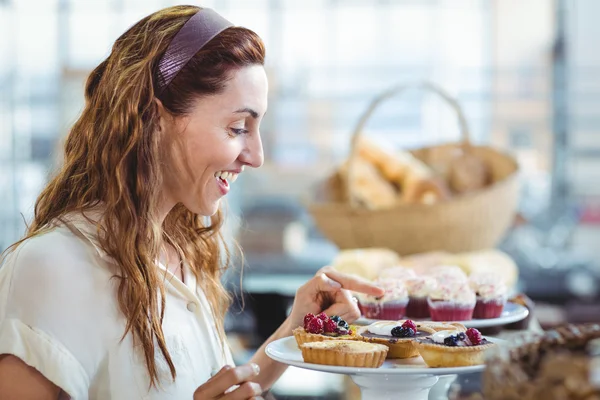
[161,66,268,216]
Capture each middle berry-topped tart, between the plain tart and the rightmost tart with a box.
[357,320,435,358]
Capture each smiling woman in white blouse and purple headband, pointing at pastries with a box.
[0,6,382,400]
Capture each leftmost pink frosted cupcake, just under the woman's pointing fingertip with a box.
[356,278,408,320]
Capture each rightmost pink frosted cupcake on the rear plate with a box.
[469,274,508,319]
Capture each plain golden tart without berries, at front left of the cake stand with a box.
[300,340,388,368]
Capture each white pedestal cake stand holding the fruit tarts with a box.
[266,337,504,400]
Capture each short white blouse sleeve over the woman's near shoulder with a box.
[0,225,124,397]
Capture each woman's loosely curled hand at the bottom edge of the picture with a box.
[194,364,263,400]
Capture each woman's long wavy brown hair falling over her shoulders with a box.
[2,6,265,386]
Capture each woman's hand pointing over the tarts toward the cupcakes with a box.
[290,267,384,329]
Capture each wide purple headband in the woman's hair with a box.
[157,8,233,93]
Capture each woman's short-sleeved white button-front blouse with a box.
[0,211,233,400]
